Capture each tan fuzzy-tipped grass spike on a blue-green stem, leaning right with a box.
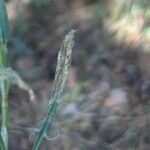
[32,30,75,150]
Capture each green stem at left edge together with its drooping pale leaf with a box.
[0,0,34,150]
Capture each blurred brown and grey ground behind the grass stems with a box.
[2,0,150,150]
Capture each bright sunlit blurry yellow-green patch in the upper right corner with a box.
[94,0,150,45]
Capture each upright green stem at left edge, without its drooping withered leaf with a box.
[0,0,9,150]
